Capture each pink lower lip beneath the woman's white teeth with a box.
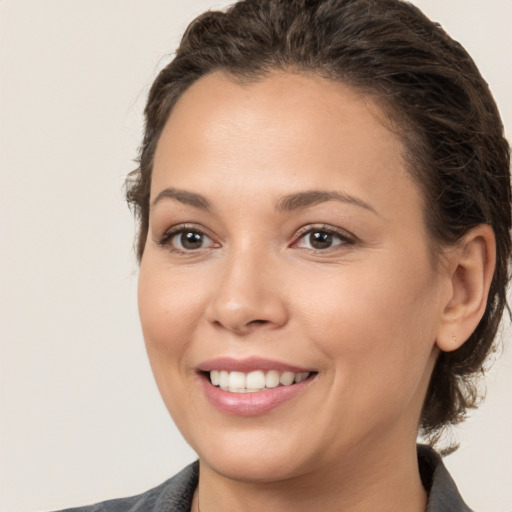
[201,375,312,416]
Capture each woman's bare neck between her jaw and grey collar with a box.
[196,445,427,512]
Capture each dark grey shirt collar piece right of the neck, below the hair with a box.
[418,445,472,512]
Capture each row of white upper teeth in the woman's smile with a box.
[210,370,309,393]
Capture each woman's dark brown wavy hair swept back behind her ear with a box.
[127,0,511,443]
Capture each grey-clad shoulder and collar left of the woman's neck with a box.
[56,462,199,512]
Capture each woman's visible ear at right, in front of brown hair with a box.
[436,224,496,352]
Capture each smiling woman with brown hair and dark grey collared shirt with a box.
[63,0,511,512]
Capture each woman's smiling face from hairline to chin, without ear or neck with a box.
[139,73,449,481]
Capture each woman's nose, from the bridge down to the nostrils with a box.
[206,248,288,336]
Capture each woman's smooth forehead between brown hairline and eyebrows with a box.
[152,72,418,222]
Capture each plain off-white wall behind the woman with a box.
[0,0,512,512]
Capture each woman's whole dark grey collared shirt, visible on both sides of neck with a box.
[61,445,471,512]
